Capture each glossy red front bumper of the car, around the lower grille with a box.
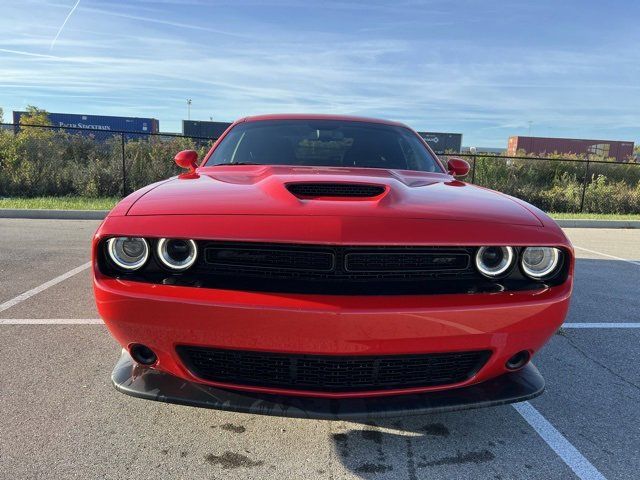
[94,272,571,399]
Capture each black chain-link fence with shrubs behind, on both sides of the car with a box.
[0,124,640,214]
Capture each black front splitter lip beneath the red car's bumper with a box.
[111,350,544,420]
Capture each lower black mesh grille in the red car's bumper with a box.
[177,346,491,392]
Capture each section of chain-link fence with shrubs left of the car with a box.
[0,124,215,197]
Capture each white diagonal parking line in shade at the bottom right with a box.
[513,402,606,480]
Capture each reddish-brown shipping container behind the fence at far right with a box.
[507,136,633,162]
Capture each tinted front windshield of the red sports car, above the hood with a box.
[206,120,442,172]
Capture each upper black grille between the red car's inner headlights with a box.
[195,241,481,295]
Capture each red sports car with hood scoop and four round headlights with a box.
[93,115,574,418]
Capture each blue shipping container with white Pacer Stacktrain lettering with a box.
[13,111,160,137]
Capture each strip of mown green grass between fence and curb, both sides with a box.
[0,197,640,220]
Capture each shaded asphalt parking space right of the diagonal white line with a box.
[531,329,640,479]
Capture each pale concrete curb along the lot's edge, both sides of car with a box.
[0,208,640,228]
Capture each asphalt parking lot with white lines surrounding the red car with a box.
[0,219,640,479]
